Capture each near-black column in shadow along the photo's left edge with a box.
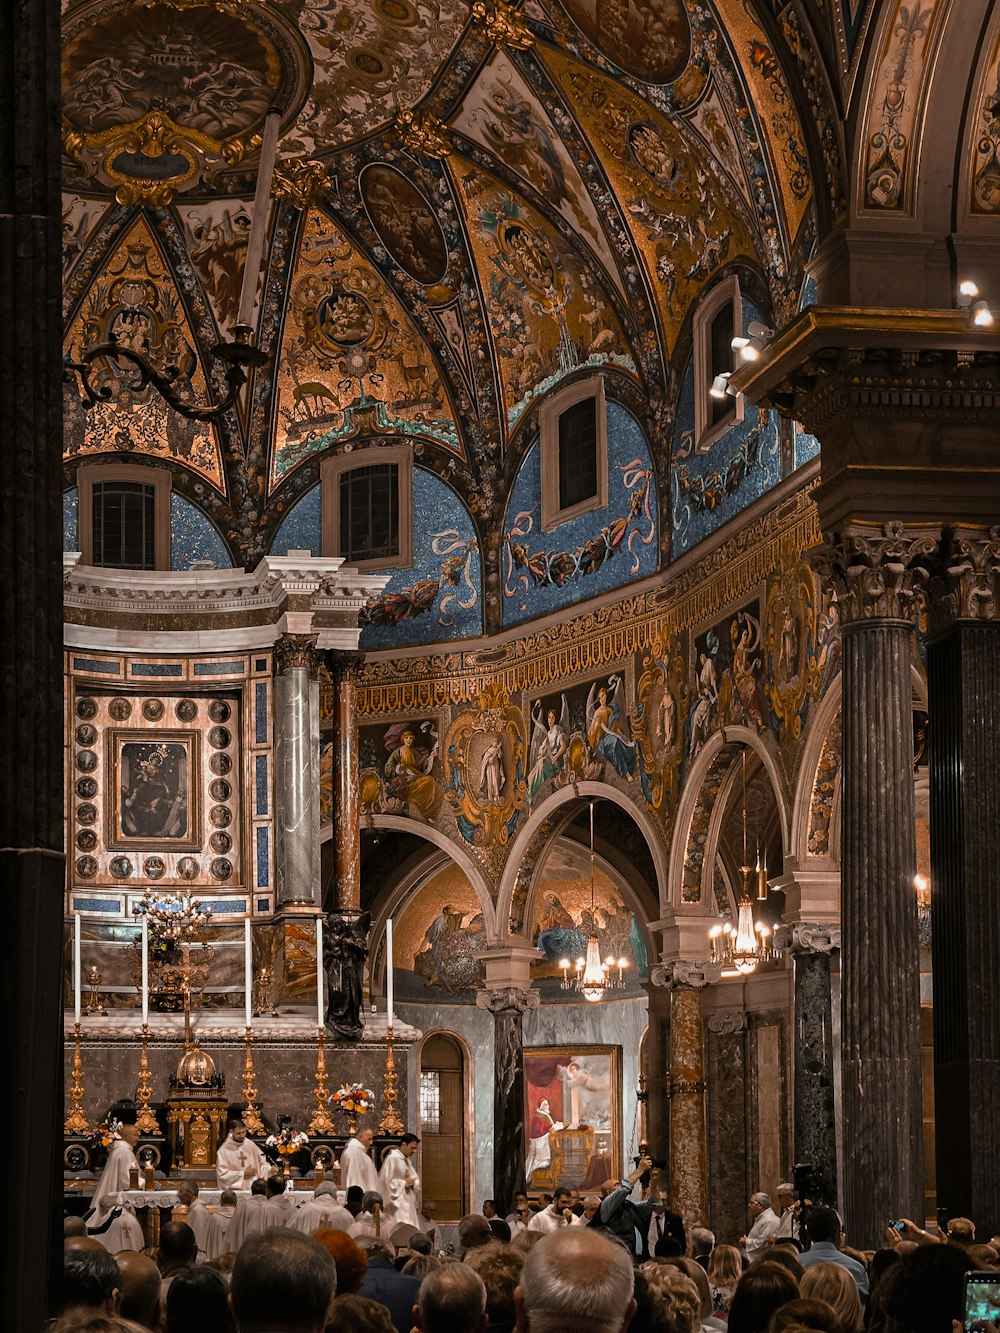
[0,0,63,1328]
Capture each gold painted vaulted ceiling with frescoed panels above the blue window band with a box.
[63,0,859,565]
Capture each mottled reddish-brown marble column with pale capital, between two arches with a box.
[651,961,721,1226]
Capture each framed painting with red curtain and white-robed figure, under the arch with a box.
[524,1046,621,1193]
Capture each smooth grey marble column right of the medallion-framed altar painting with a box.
[275,635,320,908]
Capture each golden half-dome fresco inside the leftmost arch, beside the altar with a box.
[392,865,487,1004]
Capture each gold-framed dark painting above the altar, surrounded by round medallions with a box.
[108,730,204,850]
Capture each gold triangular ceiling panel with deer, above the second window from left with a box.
[271,209,460,489]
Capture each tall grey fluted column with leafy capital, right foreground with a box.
[815,524,937,1248]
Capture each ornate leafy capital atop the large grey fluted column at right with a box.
[809,523,939,624]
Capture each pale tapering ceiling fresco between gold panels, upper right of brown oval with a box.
[451,49,621,297]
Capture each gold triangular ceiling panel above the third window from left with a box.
[448,155,635,431]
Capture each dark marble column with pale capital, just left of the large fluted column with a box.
[775,921,840,1202]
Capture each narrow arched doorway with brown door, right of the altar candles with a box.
[419,1032,467,1222]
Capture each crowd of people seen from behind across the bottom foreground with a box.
[52,1136,1000,1333]
